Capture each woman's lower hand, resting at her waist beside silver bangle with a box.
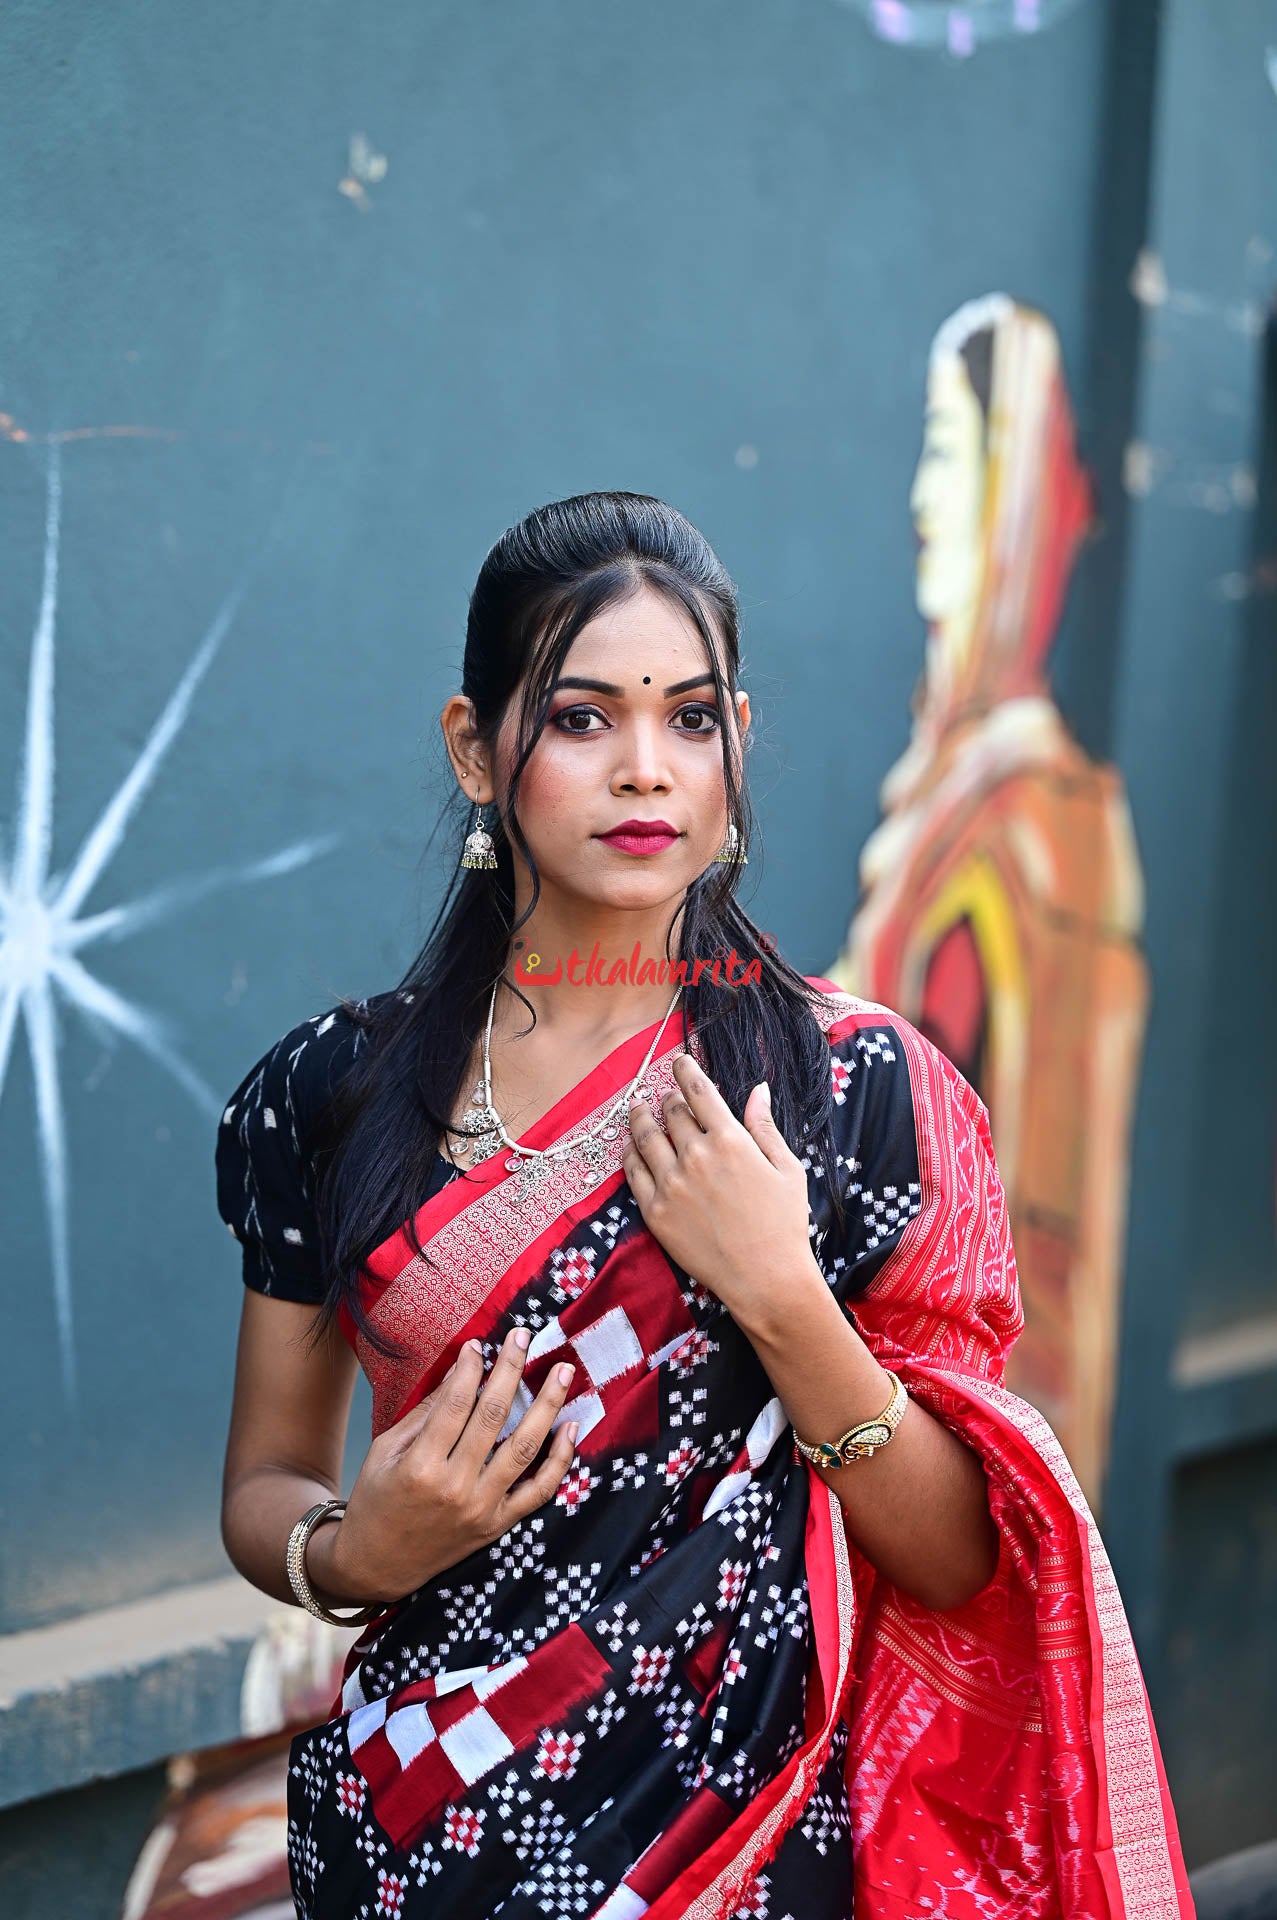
[305,1327,578,1607]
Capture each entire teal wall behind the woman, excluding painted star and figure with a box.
[0,0,1277,1914]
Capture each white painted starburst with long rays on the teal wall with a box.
[0,447,338,1402]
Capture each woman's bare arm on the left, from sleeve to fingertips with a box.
[221,1290,576,1607]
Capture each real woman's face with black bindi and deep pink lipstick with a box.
[489,586,749,910]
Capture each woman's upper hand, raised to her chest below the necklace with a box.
[620,1054,814,1325]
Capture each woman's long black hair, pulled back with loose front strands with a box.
[317,492,843,1352]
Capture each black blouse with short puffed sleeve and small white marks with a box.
[215,993,461,1306]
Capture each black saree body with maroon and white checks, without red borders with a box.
[290,1023,918,1920]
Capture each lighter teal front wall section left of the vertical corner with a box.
[0,0,1102,1628]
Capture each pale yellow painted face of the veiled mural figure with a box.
[908,353,985,626]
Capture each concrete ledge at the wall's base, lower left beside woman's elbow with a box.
[0,1574,351,1807]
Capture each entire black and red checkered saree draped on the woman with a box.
[288,981,1193,1920]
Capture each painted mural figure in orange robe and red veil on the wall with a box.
[830,294,1148,1505]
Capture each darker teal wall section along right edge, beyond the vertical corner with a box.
[1104,0,1277,1860]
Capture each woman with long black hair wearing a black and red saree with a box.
[219,493,1193,1920]
